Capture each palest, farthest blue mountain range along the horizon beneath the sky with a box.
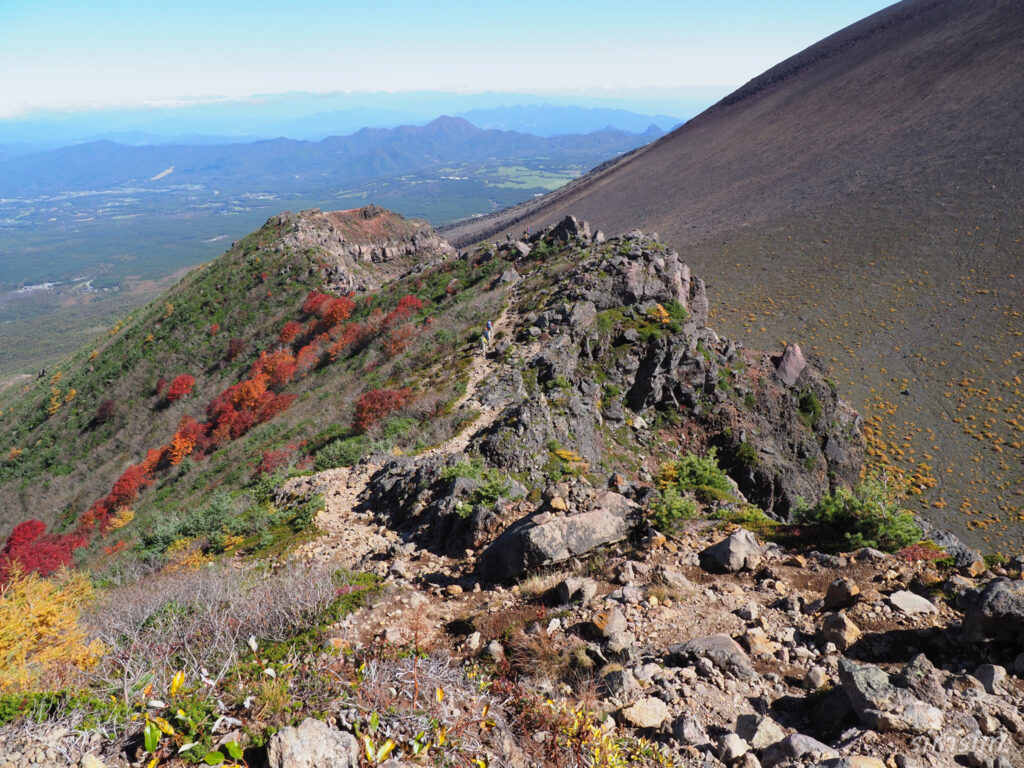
[0,88,725,159]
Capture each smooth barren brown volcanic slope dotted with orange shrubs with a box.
[445,0,1024,549]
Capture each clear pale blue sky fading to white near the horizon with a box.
[0,0,890,118]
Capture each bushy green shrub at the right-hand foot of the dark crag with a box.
[794,478,922,552]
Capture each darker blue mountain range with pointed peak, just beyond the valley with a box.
[0,117,663,198]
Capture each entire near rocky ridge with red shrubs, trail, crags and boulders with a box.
[0,208,1024,768]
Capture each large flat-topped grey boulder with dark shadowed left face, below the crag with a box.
[479,490,640,582]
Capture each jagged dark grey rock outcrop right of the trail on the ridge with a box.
[479,220,863,518]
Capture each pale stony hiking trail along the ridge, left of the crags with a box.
[281,286,532,569]
